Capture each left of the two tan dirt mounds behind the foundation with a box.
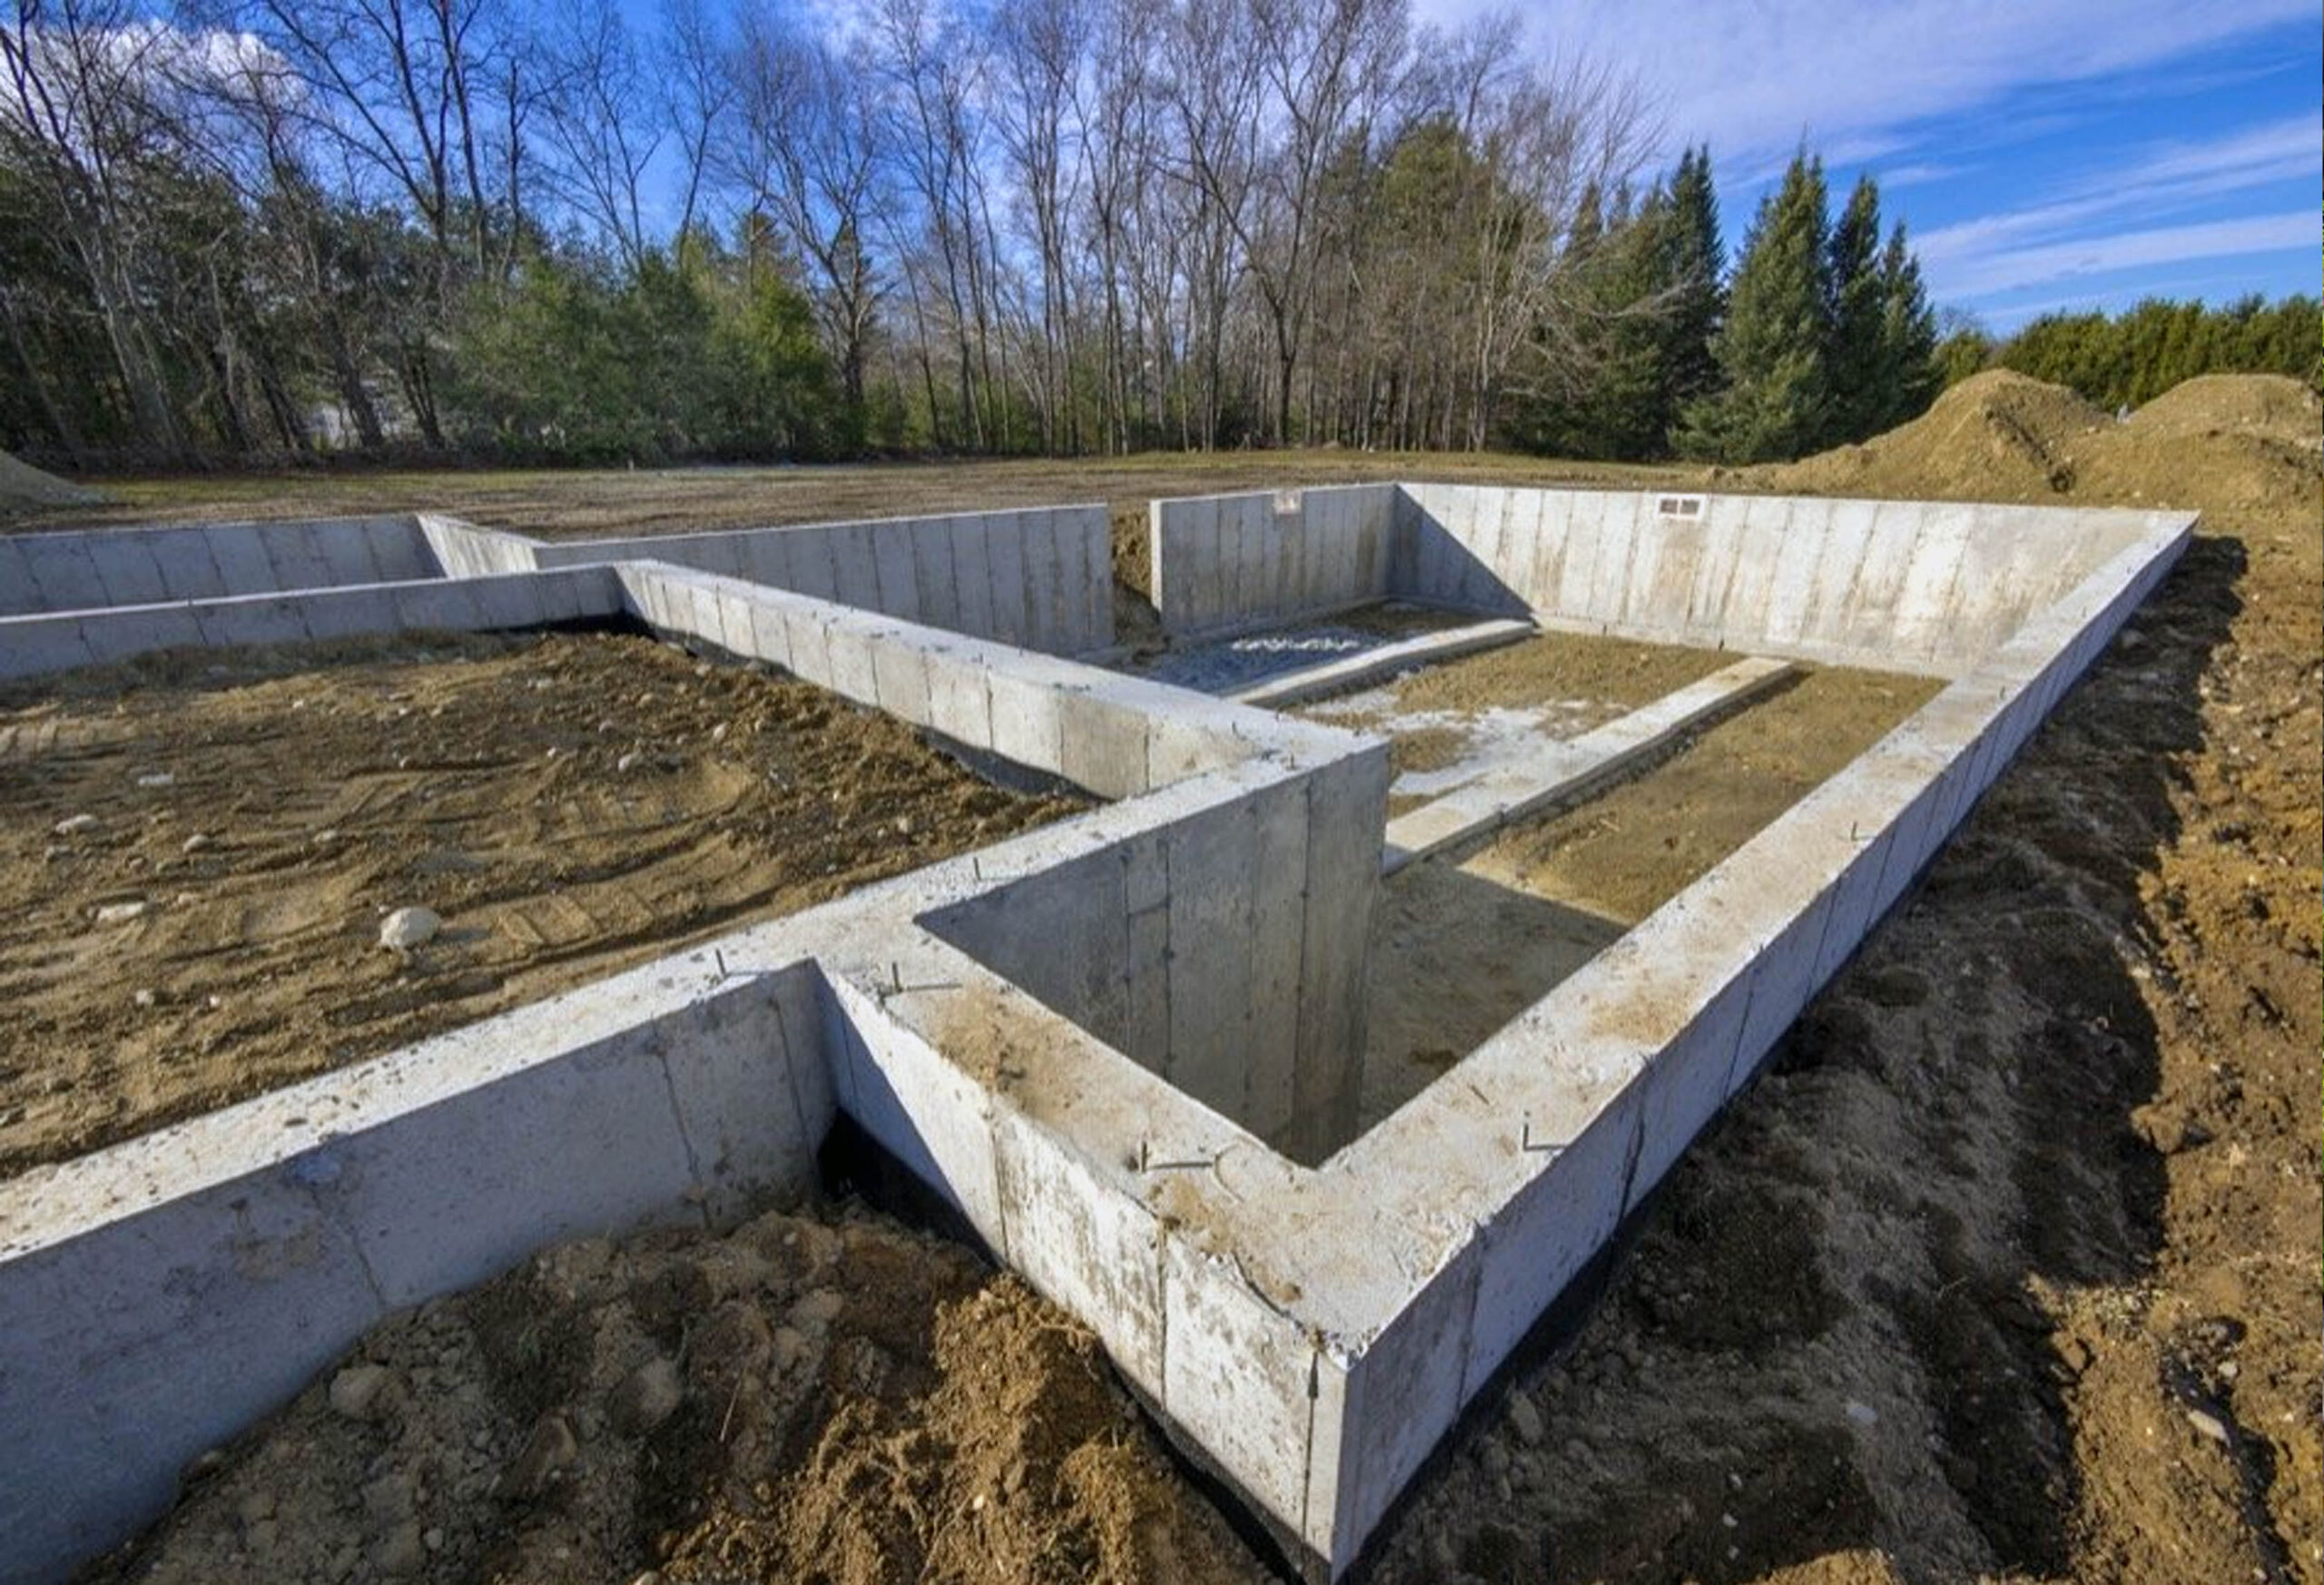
[1752,369,2112,502]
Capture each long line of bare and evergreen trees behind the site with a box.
[0,0,1935,468]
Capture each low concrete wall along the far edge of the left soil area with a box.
[0,567,625,679]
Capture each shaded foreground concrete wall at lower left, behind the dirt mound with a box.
[0,964,832,1580]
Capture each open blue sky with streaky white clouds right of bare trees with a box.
[1413,0,2324,332]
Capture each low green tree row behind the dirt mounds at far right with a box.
[1938,293,2324,409]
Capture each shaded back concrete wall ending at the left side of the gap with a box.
[535,507,1113,655]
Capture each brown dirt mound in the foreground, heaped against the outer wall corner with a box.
[95,1211,1265,1585]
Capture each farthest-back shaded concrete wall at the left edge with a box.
[0,516,439,615]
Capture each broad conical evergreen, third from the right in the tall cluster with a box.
[1682,149,1831,462]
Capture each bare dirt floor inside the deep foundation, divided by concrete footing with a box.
[1347,632,1938,1127]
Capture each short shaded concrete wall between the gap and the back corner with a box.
[1150,484,1397,635]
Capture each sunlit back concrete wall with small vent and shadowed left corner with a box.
[1390,484,2150,676]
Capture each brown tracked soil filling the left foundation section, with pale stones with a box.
[0,635,1071,1174]
